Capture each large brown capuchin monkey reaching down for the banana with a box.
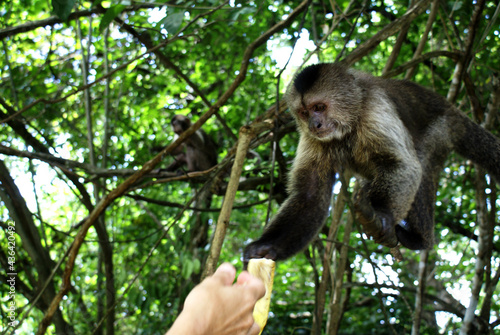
[244,64,500,261]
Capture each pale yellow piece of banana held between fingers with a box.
[247,258,276,335]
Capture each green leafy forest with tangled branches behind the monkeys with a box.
[0,0,500,334]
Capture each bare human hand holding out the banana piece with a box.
[167,263,266,335]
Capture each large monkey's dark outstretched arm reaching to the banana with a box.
[243,157,335,262]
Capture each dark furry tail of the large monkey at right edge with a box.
[452,111,500,185]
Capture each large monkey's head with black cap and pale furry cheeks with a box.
[285,63,363,142]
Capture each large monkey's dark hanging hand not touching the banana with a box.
[354,189,398,248]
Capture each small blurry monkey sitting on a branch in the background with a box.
[162,115,217,172]
